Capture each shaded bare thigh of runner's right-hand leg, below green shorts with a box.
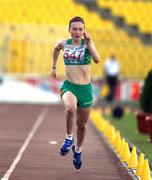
[77,108,91,124]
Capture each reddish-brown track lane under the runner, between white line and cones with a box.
[0,105,132,180]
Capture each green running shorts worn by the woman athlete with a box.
[60,80,93,108]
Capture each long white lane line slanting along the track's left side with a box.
[1,108,48,180]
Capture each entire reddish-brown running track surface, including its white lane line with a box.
[0,104,133,180]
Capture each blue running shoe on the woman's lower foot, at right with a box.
[72,145,82,169]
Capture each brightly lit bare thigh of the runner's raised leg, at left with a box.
[62,91,77,107]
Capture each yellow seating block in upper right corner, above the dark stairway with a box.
[97,0,152,33]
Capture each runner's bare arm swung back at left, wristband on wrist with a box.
[51,40,65,78]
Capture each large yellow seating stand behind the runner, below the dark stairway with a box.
[0,0,152,78]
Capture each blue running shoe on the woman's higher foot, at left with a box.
[60,139,74,156]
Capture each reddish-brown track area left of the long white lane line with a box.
[0,104,46,177]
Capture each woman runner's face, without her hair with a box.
[69,22,85,41]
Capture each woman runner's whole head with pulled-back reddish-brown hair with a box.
[69,16,85,41]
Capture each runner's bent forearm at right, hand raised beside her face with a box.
[84,32,100,63]
